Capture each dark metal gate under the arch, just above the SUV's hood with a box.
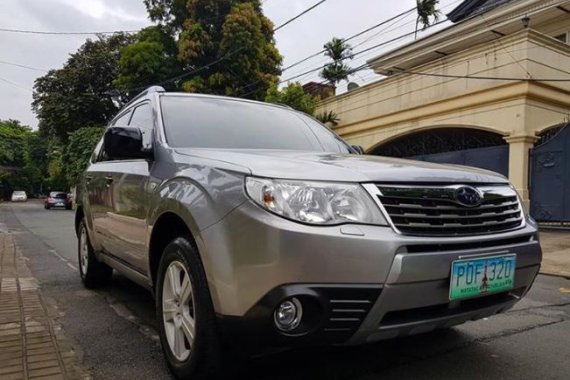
[410,144,509,177]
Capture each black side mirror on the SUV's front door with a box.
[103,127,152,160]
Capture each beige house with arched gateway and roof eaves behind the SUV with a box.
[317,0,570,211]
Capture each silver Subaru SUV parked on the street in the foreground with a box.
[76,88,542,378]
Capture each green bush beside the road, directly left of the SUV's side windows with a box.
[62,128,104,186]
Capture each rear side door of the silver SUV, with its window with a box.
[85,109,132,251]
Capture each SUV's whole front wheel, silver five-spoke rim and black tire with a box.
[156,237,222,379]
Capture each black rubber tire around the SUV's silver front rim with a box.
[156,237,223,379]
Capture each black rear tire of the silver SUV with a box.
[77,220,113,289]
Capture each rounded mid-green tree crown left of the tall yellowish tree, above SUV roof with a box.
[113,26,182,98]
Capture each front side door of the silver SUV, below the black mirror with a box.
[100,102,154,274]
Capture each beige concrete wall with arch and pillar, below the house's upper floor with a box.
[317,27,570,205]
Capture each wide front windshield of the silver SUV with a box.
[161,96,350,153]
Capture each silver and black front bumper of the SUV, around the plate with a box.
[201,202,542,345]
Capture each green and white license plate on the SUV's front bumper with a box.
[449,254,517,300]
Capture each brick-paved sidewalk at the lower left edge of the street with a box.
[0,221,91,380]
